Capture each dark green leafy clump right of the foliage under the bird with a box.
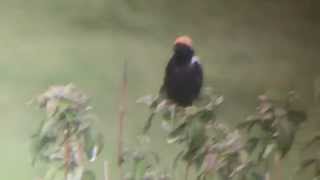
[238,91,307,180]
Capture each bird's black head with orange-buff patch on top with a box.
[174,36,194,63]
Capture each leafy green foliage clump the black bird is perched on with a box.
[138,88,249,179]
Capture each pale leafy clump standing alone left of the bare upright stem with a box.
[32,84,103,180]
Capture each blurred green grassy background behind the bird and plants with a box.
[0,0,320,180]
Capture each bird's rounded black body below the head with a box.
[164,57,203,106]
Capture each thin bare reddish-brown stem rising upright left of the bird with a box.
[118,61,128,180]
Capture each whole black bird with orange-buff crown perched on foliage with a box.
[161,36,203,107]
